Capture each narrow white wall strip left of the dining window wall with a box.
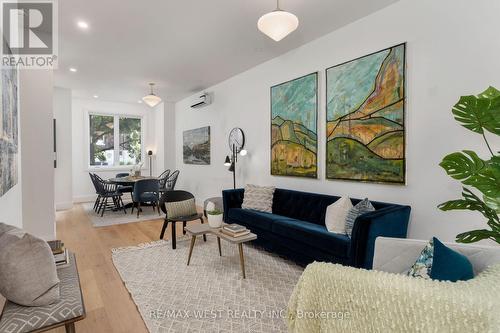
[54,87,73,210]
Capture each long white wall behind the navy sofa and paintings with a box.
[175,0,500,240]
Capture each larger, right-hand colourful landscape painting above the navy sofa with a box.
[326,44,405,184]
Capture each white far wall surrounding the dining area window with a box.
[72,98,164,202]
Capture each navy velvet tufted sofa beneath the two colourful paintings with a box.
[222,189,411,269]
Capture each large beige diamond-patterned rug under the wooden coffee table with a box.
[113,235,303,333]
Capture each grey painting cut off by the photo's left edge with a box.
[0,67,19,196]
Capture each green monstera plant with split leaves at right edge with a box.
[438,87,500,244]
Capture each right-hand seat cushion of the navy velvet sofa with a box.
[272,219,351,258]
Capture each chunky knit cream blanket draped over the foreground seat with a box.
[287,263,500,333]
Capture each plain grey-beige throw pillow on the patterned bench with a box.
[0,223,59,306]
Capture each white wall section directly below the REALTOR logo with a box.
[19,69,56,240]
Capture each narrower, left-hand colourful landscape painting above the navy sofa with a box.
[271,73,318,178]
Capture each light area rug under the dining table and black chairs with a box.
[83,203,162,227]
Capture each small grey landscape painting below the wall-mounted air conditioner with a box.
[183,126,210,165]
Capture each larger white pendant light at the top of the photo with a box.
[257,0,299,42]
